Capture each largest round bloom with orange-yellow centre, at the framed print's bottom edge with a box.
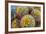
[20,15,35,27]
